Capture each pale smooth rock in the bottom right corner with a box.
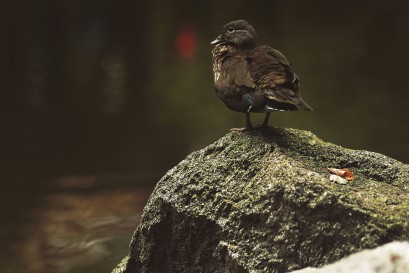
[292,242,409,273]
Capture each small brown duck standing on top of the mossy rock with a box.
[210,20,313,131]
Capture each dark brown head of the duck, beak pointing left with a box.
[210,20,257,48]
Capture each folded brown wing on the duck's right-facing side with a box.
[248,46,312,110]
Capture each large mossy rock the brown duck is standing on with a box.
[111,128,409,273]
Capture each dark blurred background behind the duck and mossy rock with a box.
[0,0,409,273]
